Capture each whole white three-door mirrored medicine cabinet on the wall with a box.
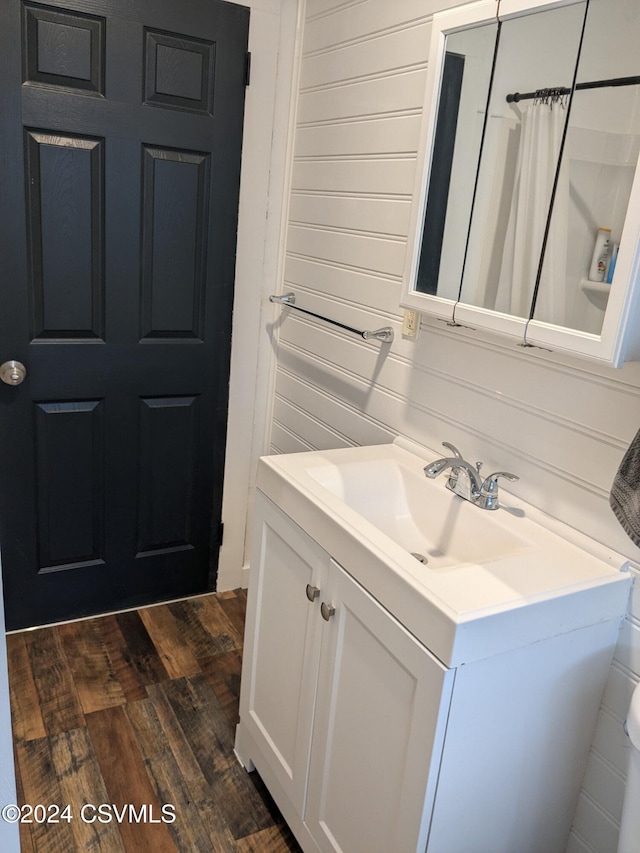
[402,0,640,367]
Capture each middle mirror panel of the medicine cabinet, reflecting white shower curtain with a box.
[460,2,586,318]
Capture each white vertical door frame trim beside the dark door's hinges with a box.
[217,0,305,590]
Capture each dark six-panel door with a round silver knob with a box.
[0,0,248,628]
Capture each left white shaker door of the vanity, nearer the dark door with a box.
[240,493,329,814]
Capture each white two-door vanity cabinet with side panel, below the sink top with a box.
[236,492,619,853]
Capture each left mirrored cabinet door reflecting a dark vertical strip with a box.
[403,0,498,320]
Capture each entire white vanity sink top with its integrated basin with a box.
[257,440,630,666]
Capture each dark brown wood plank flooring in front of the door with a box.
[7,590,300,853]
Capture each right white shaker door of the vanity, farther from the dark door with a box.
[305,563,453,853]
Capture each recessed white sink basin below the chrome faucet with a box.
[307,459,528,571]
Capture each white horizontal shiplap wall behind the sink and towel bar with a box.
[271,0,640,853]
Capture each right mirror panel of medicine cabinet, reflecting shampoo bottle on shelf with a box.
[533,0,640,335]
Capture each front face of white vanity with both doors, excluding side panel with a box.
[236,493,453,853]
